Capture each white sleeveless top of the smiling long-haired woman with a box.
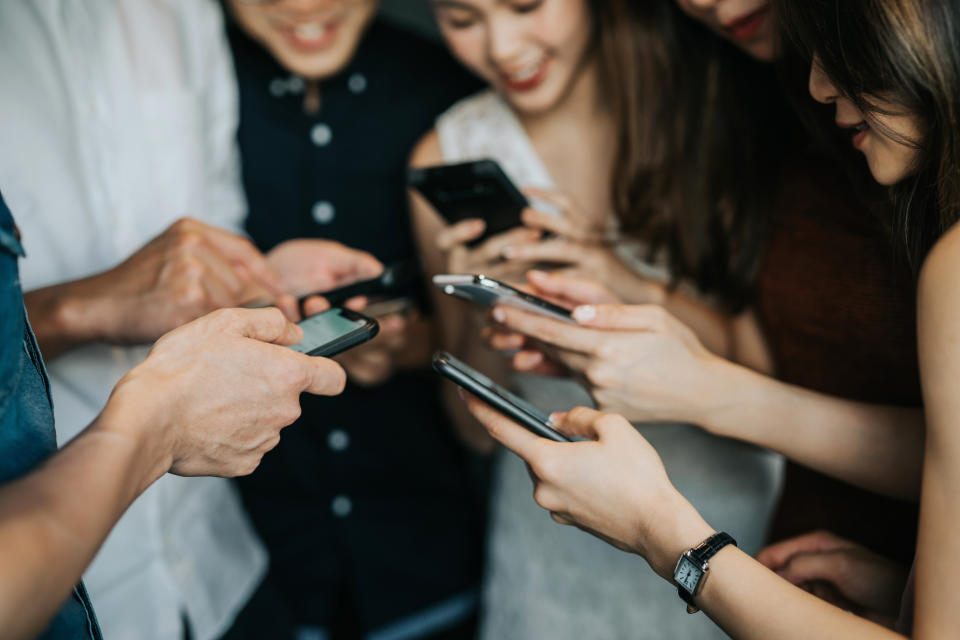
[437,91,782,640]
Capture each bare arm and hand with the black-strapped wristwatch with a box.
[470,400,908,640]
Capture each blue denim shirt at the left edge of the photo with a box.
[0,190,100,640]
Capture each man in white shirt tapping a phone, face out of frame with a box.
[0,0,380,640]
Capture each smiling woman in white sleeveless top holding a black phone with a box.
[412,0,781,640]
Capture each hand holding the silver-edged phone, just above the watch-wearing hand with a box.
[493,298,727,426]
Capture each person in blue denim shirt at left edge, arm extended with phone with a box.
[0,185,358,640]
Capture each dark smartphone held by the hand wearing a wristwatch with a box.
[433,351,573,442]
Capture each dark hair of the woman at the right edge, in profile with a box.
[777,0,960,271]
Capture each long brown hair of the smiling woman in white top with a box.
[591,0,797,310]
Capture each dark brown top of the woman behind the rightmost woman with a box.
[756,158,921,562]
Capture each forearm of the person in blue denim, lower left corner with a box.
[0,402,165,638]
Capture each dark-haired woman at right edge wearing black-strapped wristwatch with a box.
[458,0,960,638]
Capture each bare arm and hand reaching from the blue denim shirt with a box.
[0,309,345,638]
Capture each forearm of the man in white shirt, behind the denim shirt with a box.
[24,276,110,361]
